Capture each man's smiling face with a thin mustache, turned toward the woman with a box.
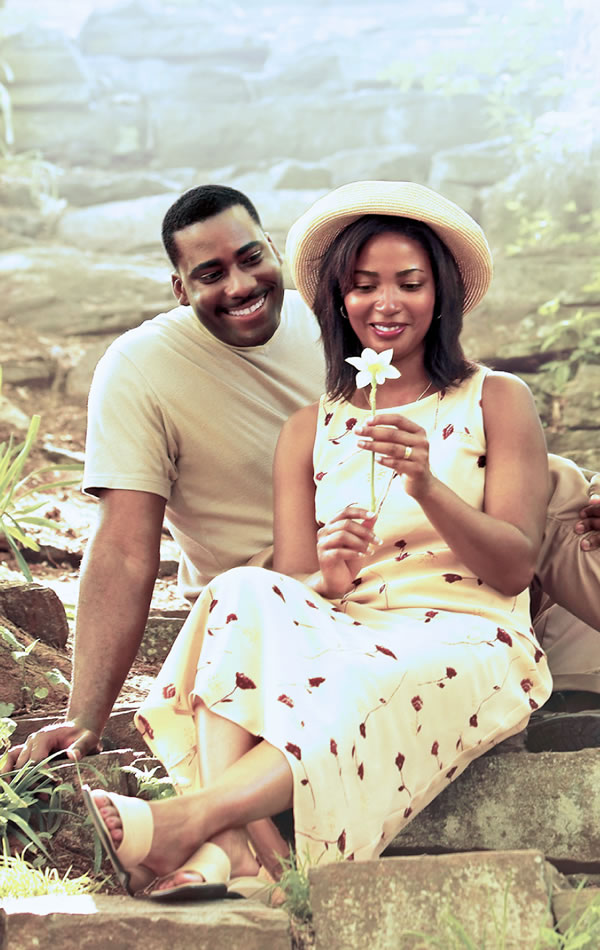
[171,205,283,346]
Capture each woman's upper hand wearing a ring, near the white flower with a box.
[354,413,434,501]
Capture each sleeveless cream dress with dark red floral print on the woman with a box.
[136,368,551,861]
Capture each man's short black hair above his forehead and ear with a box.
[162,185,262,269]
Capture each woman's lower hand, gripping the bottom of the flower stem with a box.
[315,505,381,597]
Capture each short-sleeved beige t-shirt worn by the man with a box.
[83,290,325,598]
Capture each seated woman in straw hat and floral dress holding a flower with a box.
[86,182,551,898]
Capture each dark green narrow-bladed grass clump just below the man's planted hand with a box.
[0,753,73,858]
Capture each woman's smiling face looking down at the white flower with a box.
[344,231,435,362]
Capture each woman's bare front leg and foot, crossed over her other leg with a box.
[94,727,293,876]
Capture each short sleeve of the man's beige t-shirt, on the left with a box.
[83,346,177,500]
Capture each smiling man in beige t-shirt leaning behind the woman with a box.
[3,185,600,768]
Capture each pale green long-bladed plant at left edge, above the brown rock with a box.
[0,368,81,581]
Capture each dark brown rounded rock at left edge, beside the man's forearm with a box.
[0,581,69,647]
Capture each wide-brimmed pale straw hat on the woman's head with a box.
[286,181,493,313]
